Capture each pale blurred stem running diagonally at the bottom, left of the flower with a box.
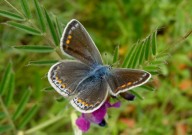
[25,115,64,134]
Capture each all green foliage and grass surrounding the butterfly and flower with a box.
[0,0,192,135]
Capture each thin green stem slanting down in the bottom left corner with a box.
[0,96,17,134]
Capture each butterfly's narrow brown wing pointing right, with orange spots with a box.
[106,68,151,96]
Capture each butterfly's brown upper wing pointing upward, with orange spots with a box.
[60,19,102,66]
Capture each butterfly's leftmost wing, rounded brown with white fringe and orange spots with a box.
[48,61,90,96]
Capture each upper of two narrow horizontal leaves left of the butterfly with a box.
[14,45,54,53]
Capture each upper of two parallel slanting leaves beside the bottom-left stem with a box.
[13,89,31,120]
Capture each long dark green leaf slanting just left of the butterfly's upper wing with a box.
[45,10,59,46]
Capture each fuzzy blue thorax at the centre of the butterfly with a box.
[90,65,110,78]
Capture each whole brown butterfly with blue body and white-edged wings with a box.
[48,19,151,113]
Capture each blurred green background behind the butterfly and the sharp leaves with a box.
[0,0,192,135]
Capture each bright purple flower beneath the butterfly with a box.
[76,101,121,132]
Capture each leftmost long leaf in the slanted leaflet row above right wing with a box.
[122,45,136,68]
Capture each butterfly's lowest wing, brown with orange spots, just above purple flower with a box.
[71,76,108,113]
